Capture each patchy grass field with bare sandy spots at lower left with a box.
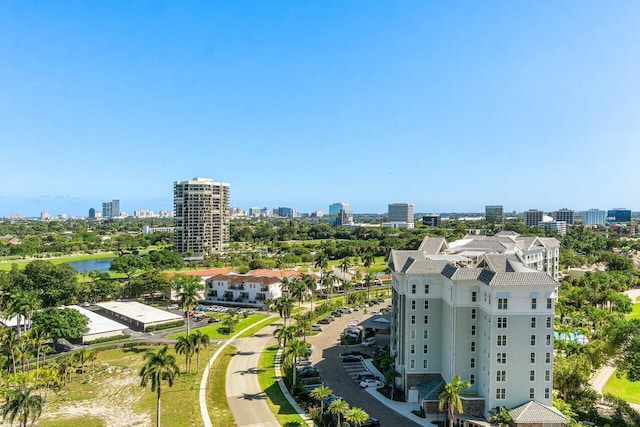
[37,346,218,427]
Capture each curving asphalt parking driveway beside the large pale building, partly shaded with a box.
[307,303,419,427]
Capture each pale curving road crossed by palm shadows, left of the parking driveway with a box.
[228,325,280,427]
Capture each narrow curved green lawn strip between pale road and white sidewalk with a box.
[258,345,306,427]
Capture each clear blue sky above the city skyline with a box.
[0,1,640,216]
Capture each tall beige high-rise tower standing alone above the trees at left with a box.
[173,178,229,256]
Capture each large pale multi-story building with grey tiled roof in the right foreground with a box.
[389,233,567,426]
